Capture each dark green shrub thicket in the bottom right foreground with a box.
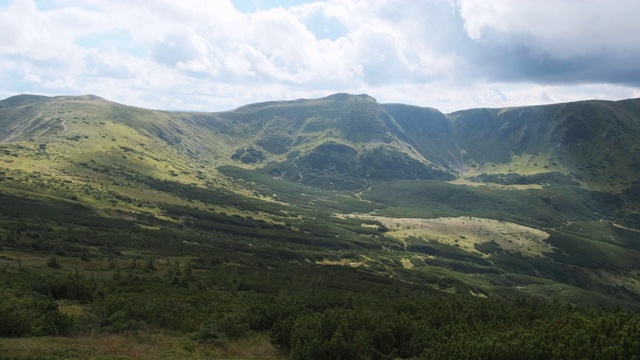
[272,297,640,359]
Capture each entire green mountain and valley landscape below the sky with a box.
[0,94,640,359]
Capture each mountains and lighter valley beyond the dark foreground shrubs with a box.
[0,94,640,307]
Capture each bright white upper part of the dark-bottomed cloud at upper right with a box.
[459,0,640,57]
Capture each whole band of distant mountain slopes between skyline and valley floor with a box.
[0,94,640,191]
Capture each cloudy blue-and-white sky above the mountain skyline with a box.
[0,0,640,112]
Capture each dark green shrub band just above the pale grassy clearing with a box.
[364,181,623,227]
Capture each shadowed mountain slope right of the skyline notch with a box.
[450,99,640,189]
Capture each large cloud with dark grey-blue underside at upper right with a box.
[458,0,640,86]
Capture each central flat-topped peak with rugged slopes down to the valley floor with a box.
[219,94,455,189]
